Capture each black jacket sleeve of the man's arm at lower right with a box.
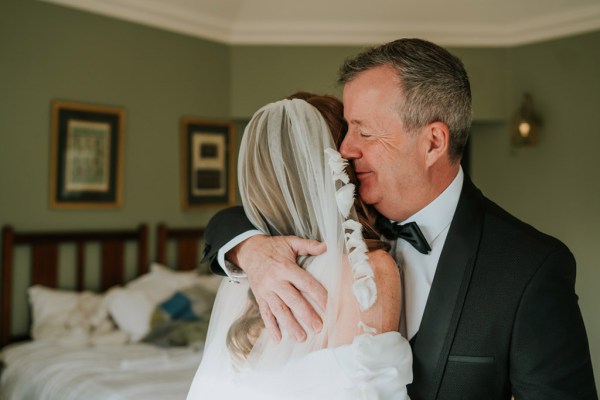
[510,245,598,400]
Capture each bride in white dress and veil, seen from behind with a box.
[187,93,412,400]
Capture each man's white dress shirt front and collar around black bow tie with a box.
[390,168,464,340]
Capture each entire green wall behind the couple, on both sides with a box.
[0,0,600,382]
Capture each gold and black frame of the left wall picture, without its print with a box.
[50,101,125,209]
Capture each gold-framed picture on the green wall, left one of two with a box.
[50,101,125,208]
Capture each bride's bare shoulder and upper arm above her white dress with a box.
[361,250,402,333]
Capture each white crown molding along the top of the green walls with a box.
[41,0,600,47]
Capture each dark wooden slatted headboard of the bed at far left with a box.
[0,224,148,348]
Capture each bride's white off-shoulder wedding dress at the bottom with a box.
[187,280,412,400]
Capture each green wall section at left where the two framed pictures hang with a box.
[0,0,230,238]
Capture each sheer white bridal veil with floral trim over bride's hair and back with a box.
[188,99,410,399]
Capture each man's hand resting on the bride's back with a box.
[227,235,327,342]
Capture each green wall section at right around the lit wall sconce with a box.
[472,32,600,382]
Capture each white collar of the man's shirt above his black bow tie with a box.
[402,167,464,245]
